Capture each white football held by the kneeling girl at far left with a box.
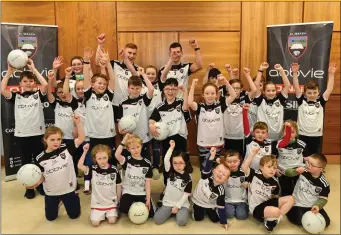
[17,164,42,186]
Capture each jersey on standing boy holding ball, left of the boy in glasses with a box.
[117,93,151,143]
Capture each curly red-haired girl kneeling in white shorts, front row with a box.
[78,144,122,227]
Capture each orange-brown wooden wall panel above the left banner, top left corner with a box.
[1,2,56,25]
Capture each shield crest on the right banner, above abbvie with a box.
[288,32,308,60]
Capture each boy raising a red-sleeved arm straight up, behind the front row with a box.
[243,104,277,170]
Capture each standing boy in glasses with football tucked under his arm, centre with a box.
[149,78,193,185]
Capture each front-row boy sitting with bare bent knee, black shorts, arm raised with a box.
[242,151,295,232]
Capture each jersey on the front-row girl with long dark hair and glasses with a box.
[162,171,192,208]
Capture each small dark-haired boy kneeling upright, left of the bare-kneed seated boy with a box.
[217,149,249,220]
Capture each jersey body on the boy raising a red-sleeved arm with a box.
[244,134,277,170]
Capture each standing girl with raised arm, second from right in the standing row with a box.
[255,64,290,141]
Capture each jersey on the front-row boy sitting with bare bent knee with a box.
[248,169,280,214]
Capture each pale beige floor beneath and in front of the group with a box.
[1,165,340,234]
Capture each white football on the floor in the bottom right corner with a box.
[301,211,326,234]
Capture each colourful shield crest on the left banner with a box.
[17,33,38,59]
